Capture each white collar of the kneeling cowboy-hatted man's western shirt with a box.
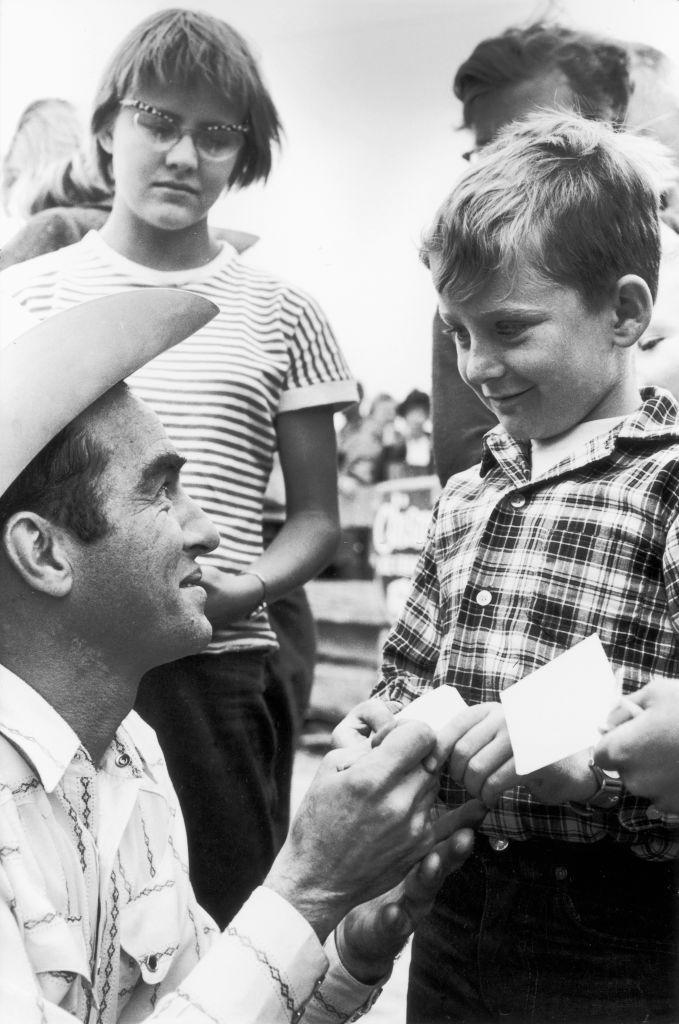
[0,665,162,793]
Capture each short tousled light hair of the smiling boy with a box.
[422,112,669,308]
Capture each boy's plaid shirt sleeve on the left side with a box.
[373,499,443,703]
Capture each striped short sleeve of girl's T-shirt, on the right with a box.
[279,293,358,413]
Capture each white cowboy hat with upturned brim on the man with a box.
[0,288,217,495]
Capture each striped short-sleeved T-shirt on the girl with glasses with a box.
[0,231,356,653]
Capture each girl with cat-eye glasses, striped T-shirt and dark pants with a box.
[2,8,356,925]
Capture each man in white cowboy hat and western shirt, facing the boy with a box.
[0,289,478,1024]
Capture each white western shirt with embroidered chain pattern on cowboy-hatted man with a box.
[0,666,377,1024]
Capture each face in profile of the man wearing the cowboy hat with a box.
[70,391,219,672]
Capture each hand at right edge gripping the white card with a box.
[594,679,679,814]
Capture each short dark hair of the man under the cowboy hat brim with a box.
[0,409,111,544]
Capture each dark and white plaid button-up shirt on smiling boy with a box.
[375,388,679,859]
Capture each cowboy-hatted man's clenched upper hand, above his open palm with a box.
[265,722,446,941]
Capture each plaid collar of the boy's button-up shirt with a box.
[479,387,679,487]
